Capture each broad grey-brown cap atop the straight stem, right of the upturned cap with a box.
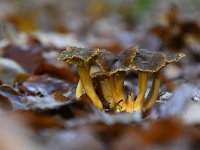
[131,49,166,73]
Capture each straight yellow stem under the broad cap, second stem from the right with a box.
[134,71,148,111]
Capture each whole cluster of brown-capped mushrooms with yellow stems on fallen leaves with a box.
[58,47,185,112]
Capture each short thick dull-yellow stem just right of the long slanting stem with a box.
[100,79,114,108]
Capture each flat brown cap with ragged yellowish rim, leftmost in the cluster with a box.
[58,47,99,64]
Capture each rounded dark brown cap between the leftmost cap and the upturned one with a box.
[95,49,118,73]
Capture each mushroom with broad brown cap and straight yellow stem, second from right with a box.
[131,49,166,111]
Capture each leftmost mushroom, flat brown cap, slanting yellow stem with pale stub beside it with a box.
[58,47,103,110]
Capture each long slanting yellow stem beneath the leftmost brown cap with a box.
[77,64,103,110]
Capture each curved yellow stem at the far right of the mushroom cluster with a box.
[142,73,160,110]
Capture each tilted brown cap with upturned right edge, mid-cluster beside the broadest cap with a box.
[110,46,138,74]
